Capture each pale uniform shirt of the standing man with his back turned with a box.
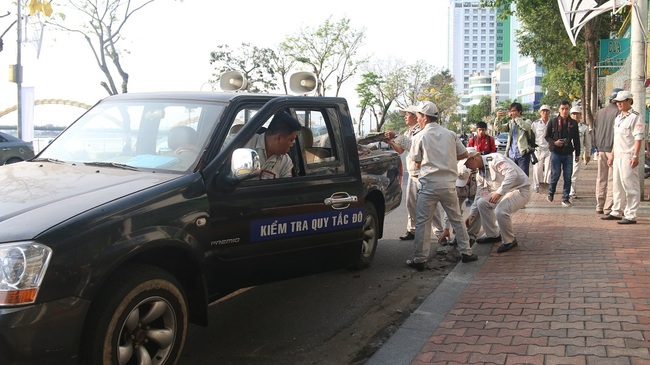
[410,123,467,190]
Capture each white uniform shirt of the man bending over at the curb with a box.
[469,153,530,217]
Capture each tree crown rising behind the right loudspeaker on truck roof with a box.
[281,17,367,96]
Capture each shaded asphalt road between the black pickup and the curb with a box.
[175,175,454,365]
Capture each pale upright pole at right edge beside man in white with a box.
[630,0,648,199]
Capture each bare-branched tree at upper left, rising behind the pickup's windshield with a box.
[46,0,166,95]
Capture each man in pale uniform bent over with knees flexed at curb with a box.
[465,148,531,253]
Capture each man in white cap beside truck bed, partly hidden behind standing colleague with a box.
[384,105,444,241]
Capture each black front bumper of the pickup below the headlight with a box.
[0,298,90,365]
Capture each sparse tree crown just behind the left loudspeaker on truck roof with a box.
[210,43,278,92]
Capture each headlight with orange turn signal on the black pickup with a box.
[0,242,52,306]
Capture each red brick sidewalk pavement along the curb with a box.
[412,164,650,365]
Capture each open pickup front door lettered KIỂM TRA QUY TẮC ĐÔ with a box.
[204,104,363,287]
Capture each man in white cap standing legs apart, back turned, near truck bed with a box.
[406,102,478,271]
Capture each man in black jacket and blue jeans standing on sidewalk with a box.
[546,100,580,207]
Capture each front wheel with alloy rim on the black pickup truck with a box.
[82,265,188,365]
